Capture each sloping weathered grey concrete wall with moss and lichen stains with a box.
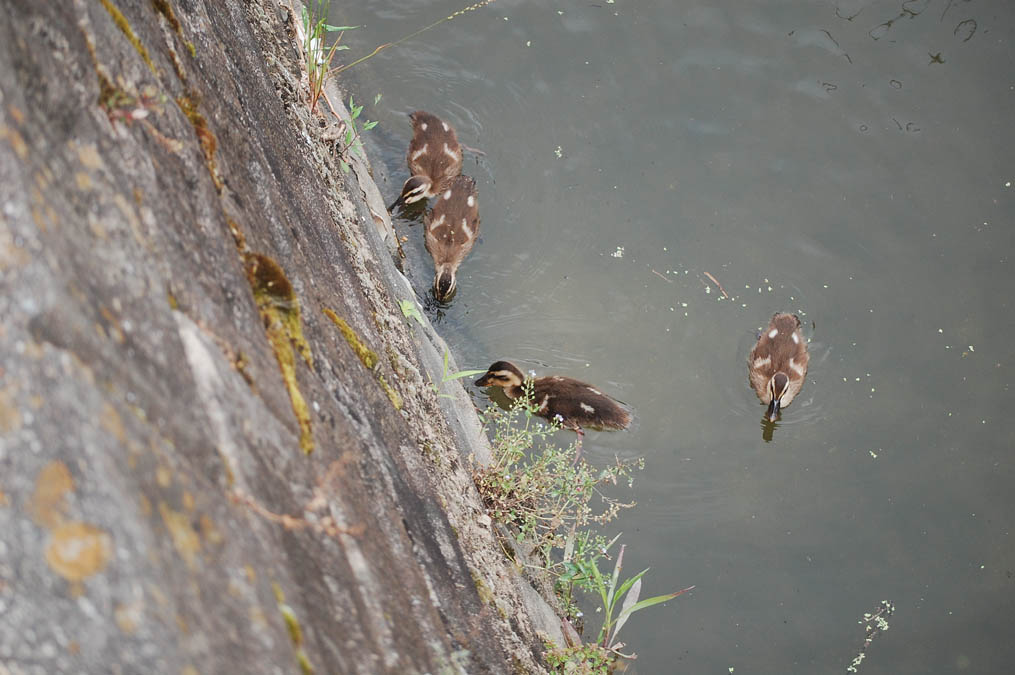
[0,0,554,674]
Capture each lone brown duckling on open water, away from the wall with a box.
[747,314,810,422]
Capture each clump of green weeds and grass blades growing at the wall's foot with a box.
[473,382,694,675]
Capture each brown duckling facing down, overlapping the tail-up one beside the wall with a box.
[423,176,479,302]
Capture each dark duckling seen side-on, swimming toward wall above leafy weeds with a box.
[476,361,631,449]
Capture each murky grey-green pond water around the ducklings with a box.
[335,0,1015,673]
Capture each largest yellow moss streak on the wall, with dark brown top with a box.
[244,253,314,455]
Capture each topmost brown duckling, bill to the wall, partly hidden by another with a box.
[388,111,462,211]
